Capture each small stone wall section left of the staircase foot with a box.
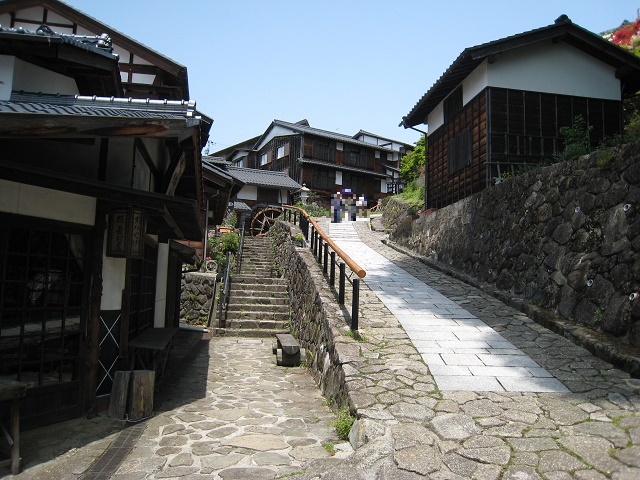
[180,269,216,325]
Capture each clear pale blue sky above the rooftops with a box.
[64,0,640,152]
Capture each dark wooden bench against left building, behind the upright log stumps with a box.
[129,328,178,378]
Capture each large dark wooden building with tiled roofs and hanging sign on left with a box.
[0,0,219,428]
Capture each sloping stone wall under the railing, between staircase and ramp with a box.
[269,222,359,405]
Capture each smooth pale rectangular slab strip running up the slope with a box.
[329,222,568,392]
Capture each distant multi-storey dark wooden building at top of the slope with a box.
[215,120,412,204]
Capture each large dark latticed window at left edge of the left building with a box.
[0,219,89,388]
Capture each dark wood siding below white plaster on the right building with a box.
[427,88,622,208]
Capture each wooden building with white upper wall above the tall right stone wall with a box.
[402,15,640,208]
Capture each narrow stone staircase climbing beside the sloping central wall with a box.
[215,237,290,337]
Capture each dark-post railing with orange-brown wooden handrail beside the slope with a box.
[283,205,367,331]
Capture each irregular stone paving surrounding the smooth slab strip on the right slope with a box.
[301,222,640,480]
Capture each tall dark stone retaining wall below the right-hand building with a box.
[390,143,640,350]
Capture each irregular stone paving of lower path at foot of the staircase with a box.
[111,337,351,480]
